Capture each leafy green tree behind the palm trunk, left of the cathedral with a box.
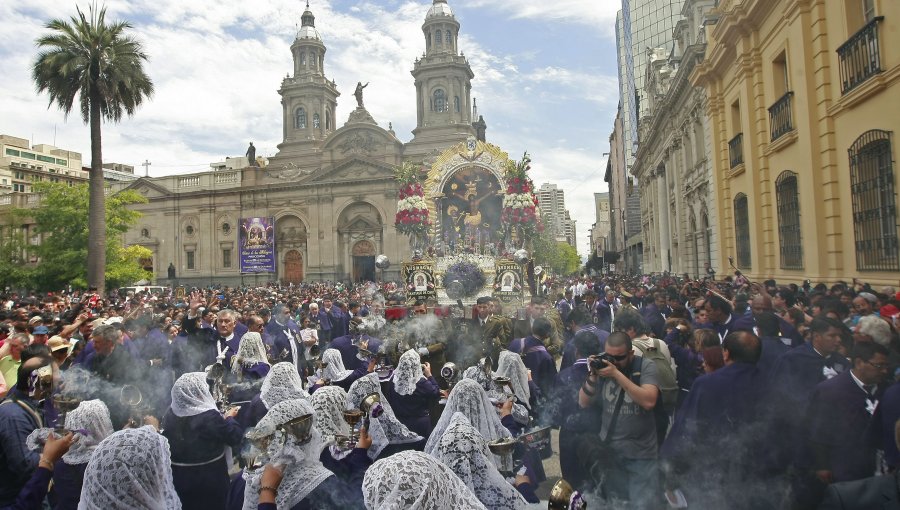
[15,182,153,290]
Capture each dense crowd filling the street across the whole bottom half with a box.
[0,274,900,510]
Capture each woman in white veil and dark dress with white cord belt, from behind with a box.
[163,372,243,510]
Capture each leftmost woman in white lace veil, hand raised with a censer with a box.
[26,400,113,510]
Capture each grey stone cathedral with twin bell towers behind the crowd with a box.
[113,0,485,286]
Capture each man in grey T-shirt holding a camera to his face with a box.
[578,331,659,508]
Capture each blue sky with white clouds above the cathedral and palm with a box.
[0,0,619,254]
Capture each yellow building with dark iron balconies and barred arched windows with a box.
[691,0,900,285]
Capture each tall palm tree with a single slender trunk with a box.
[32,6,153,292]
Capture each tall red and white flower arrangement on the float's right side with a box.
[501,152,544,238]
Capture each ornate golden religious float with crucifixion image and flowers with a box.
[384,138,544,308]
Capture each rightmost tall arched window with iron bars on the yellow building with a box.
[847,129,900,271]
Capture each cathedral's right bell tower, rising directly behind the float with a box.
[405,0,475,160]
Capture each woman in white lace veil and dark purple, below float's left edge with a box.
[384,349,441,437]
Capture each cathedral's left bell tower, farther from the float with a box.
[278,2,340,155]
